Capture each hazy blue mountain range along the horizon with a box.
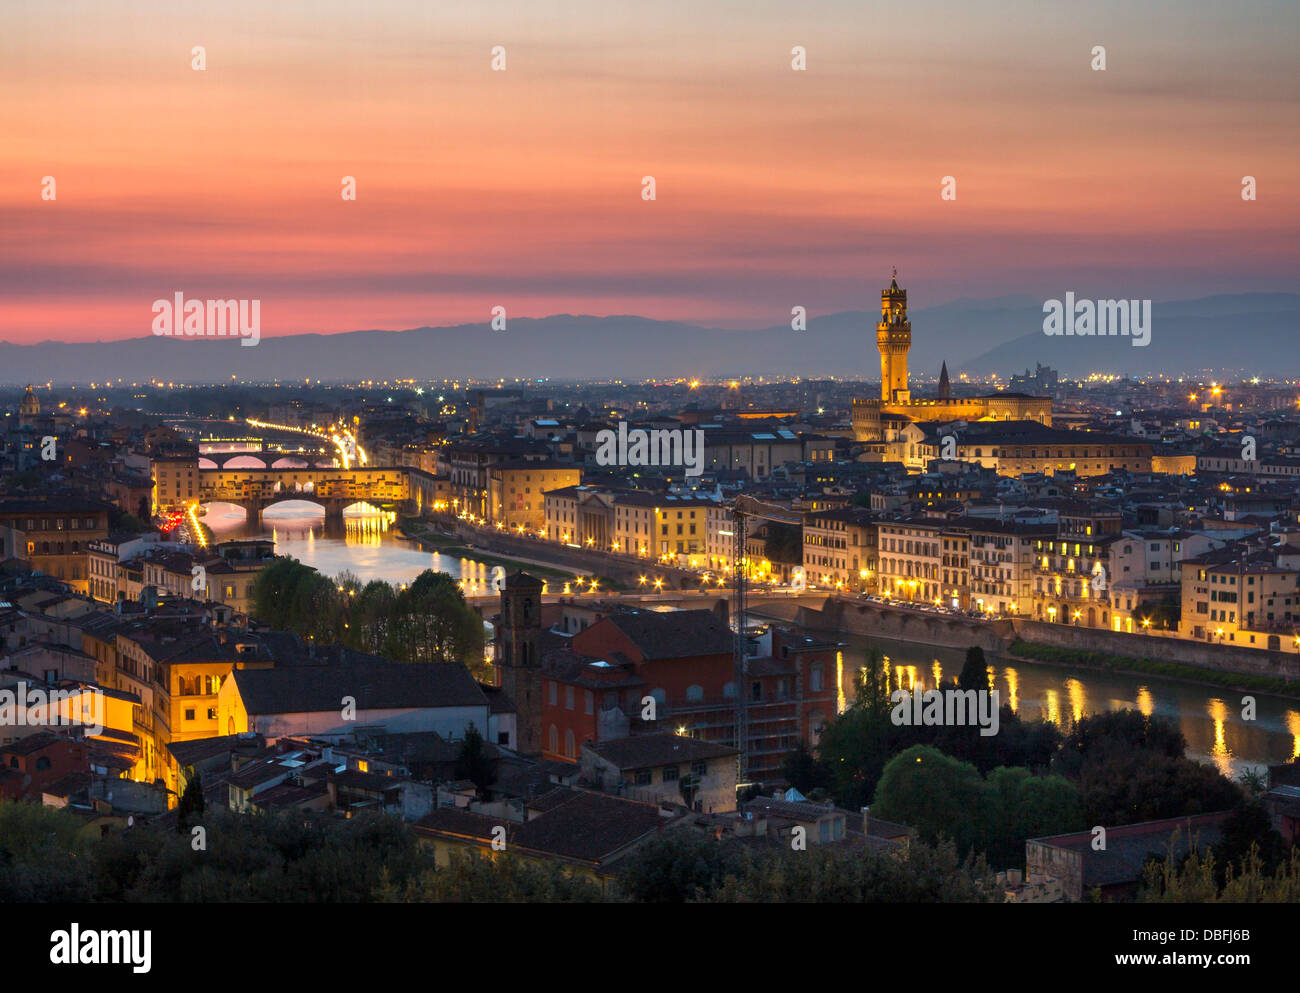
[0,292,1300,385]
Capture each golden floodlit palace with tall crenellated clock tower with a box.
[853,270,1052,442]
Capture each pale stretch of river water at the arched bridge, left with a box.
[203,500,506,595]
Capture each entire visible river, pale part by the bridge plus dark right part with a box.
[203,503,1300,777]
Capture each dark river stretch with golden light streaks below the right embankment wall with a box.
[845,637,1300,779]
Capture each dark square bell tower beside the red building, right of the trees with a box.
[497,572,542,755]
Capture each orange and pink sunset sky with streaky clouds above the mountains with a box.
[0,0,1300,343]
